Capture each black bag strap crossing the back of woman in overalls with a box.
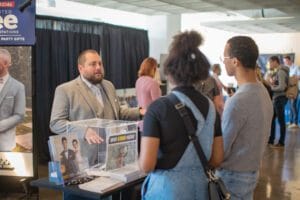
[167,93,212,179]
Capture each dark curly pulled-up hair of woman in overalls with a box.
[164,31,210,86]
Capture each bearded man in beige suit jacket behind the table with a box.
[50,49,145,168]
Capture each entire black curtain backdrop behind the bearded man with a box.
[33,16,149,162]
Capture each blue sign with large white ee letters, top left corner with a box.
[0,0,35,46]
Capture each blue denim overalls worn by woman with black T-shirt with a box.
[142,91,216,200]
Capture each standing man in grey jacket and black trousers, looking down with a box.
[268,56,289,148]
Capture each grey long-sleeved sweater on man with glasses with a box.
[221,83,273,172]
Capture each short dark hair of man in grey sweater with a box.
[227,36,258,69]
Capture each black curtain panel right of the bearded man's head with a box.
[101,25,149,89]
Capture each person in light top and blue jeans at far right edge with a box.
[283,55,300,128]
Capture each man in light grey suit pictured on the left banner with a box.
[0,48,26,151]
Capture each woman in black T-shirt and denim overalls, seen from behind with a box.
[139,31,223,200]
